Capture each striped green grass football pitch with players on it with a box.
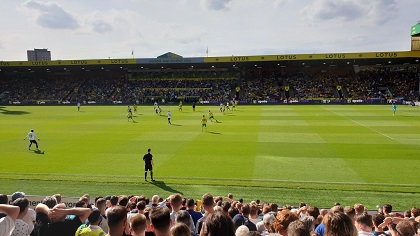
[0,105,420,209]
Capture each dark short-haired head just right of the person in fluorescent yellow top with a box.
[107,206,127,236]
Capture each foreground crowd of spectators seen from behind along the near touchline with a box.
[0,192,420,236]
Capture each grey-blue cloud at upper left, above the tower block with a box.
[22,0,80,30]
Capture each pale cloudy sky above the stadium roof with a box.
[0,0,420,61]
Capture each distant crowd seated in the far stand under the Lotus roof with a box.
[0,69,419,103]
